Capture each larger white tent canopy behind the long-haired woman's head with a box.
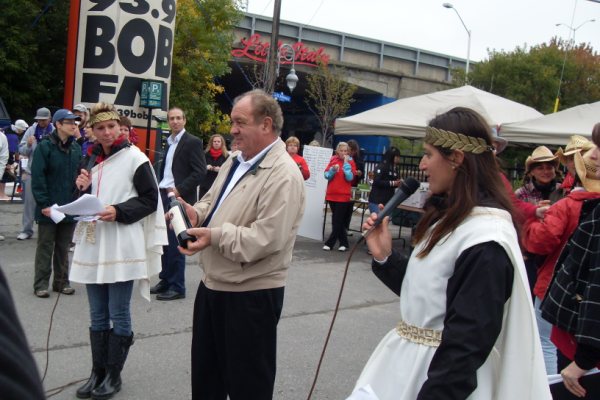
[335,86,542,138]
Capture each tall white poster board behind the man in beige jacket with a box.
[298,146,333,241]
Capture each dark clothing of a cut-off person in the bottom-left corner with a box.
[0,264,46,400]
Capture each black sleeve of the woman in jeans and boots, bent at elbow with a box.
[113,162,158,224]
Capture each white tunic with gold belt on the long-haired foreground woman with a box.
[356,207,551,400]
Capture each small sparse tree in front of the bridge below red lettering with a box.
[306,63,356,146]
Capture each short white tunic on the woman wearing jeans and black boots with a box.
[69,146,168,300]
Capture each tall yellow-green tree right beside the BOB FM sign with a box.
[169,0,241,136]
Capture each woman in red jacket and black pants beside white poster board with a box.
[323,142,356,251]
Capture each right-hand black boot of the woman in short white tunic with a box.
[92,331,133,400]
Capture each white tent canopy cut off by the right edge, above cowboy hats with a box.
[500,101,600,146]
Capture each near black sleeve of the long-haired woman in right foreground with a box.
[417,242,514,400]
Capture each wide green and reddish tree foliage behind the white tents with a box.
[453,38,600,113]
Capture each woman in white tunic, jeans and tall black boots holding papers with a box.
[70,103,167,399]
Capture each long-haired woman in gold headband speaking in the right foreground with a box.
[356,108,550,400]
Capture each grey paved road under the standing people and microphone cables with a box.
[0,202,410,400]
